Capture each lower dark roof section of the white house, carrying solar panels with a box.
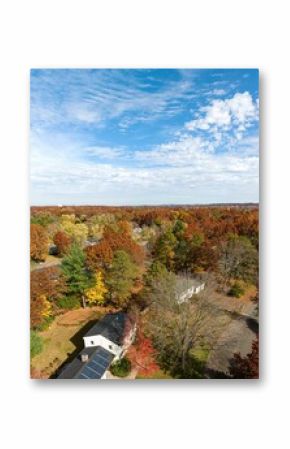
[58,346,114,379]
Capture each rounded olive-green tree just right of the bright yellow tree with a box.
[106,251,138,307]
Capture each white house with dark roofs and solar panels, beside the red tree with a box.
[57,312,136,379]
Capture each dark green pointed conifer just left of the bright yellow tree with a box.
[61,243,92,307]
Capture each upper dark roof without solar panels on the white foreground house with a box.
[84,312,126,346]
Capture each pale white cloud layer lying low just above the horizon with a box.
[31,131,258,204]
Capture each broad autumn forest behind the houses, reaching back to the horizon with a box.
[30,207,258,325]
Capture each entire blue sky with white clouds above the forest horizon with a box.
[30,69,259,205]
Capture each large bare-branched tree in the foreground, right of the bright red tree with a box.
[147,273,227,377]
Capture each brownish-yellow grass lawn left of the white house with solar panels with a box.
[31,307,108,378]
